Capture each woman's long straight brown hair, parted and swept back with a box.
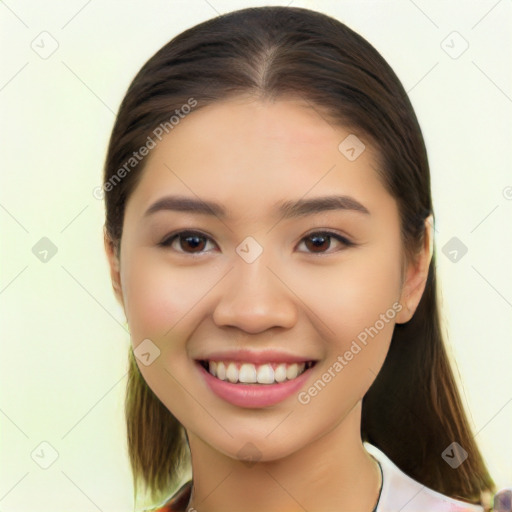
[104,7,495,503]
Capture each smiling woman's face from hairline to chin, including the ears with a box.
[109,94,428,460]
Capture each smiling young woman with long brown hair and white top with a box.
[103,7,506,512]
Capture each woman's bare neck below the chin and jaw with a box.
[187,401,381,512]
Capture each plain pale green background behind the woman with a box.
[0,0,512,512]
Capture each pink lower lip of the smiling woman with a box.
[196,361,314,408]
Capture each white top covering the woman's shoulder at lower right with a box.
[364,442,484,512]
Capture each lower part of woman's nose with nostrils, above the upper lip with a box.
[213,257,298,334]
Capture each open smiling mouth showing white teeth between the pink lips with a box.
[197,360,317,384]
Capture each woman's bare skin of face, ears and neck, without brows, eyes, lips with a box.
[105,97,432,512]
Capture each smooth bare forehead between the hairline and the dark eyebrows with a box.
[125,97,385,221]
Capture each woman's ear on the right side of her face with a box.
[396,214,434,324]
